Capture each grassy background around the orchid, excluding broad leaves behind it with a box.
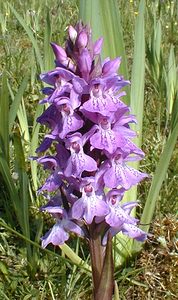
[0,0,178,300]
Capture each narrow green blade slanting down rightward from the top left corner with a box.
[9,3,44,72]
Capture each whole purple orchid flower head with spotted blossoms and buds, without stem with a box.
[33,22,147,247]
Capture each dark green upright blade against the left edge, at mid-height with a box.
[0,72,9,162]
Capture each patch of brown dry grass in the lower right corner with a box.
[122,215,178,300]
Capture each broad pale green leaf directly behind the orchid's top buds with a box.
[79,0,129,103]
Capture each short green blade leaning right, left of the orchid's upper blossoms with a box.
[9,75,29,132]
